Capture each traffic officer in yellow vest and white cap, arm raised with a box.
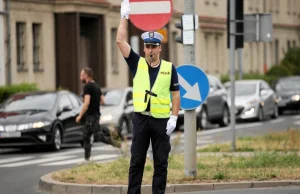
[117,0,180,194]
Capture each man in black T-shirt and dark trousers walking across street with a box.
[76,67,104,161]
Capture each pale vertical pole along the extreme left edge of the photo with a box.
[0,0,5,86]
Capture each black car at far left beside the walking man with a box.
[0,91,84,150]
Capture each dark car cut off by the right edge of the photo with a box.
[275,76,300,114]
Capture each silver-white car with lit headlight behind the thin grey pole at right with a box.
[227,80,278,121]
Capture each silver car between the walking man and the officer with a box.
[100,87,134,138]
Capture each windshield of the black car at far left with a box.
[0,93,57,112]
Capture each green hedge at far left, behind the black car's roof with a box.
[0,83,39,103]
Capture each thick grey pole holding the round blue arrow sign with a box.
[183,0,197,177]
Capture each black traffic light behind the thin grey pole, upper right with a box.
[227,0,244,49]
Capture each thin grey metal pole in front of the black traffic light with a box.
[229,0,236,151]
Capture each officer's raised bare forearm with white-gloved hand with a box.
[116,0,130,58]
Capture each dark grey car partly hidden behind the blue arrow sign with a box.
[178,75,230,129]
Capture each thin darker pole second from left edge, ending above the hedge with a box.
[6,0,11,84]
